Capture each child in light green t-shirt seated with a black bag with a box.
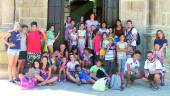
[90,59,109,80]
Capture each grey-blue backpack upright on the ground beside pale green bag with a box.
[110,74,121,90]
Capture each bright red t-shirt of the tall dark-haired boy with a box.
[27,31,43,53]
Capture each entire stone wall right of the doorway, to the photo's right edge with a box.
[119,0,170,63]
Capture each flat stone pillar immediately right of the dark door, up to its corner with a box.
[119,0,149,63]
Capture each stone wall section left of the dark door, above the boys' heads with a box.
[16,0,48,28]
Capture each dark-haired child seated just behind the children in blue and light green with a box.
[82,48,93,69]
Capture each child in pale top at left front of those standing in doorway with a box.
[69,27,78,50]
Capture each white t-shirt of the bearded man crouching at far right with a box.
[144,59,162,73]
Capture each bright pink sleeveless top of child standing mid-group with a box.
[93,35,102,52]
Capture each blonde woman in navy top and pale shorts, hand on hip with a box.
[4,22,21,83]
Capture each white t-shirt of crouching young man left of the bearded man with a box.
[125,58,140,71]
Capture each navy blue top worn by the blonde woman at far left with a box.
[9,31,21,49]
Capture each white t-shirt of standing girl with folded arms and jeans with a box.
[117,42,127,59]
